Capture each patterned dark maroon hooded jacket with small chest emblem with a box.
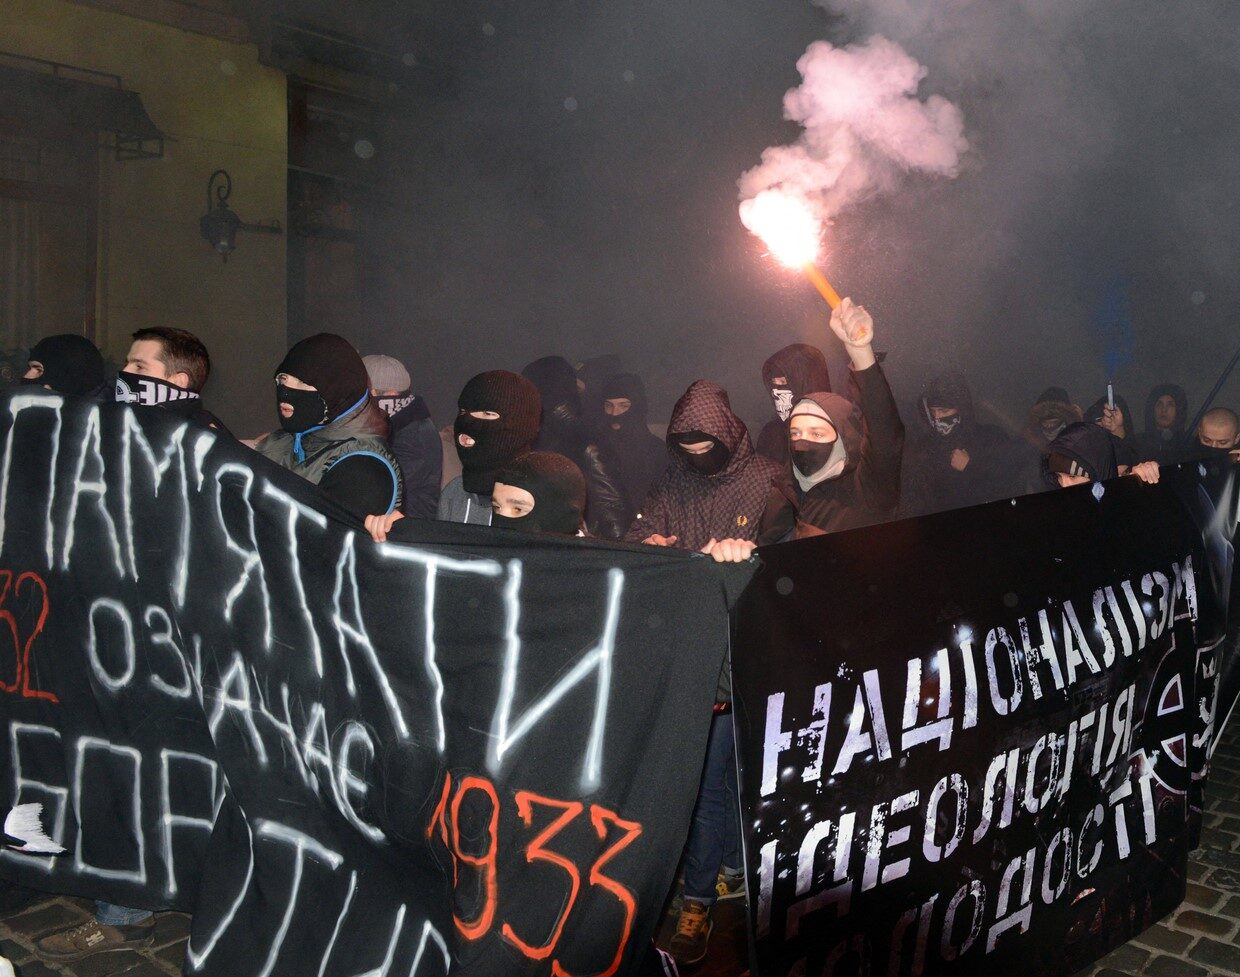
[625,379,779,549]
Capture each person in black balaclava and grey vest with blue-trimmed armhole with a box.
[255,332,402,518]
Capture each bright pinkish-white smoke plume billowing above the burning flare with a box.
[739,37,968,231]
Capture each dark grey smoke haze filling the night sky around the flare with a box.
[364,0,1240,433]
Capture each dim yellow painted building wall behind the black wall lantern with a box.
[0,0,288,436]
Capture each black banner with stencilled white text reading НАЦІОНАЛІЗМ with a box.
[734,466,1231,977]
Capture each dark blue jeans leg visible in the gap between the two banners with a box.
[684,713,743,904]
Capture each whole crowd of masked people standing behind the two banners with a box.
[12,307,1240,963]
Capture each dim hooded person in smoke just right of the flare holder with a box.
[900,372,1024,516]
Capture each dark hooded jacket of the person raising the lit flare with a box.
[758,363,904,546]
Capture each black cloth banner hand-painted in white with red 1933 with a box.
[0,392,728,977]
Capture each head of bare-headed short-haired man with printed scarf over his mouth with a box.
[117,326,232,436]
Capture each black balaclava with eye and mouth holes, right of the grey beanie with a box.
[453,369,542,495]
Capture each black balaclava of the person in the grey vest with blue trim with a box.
[275,332,371,435]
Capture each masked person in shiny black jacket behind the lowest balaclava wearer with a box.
[521,356,627,539]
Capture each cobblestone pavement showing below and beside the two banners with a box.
[0,723,1240,977]
